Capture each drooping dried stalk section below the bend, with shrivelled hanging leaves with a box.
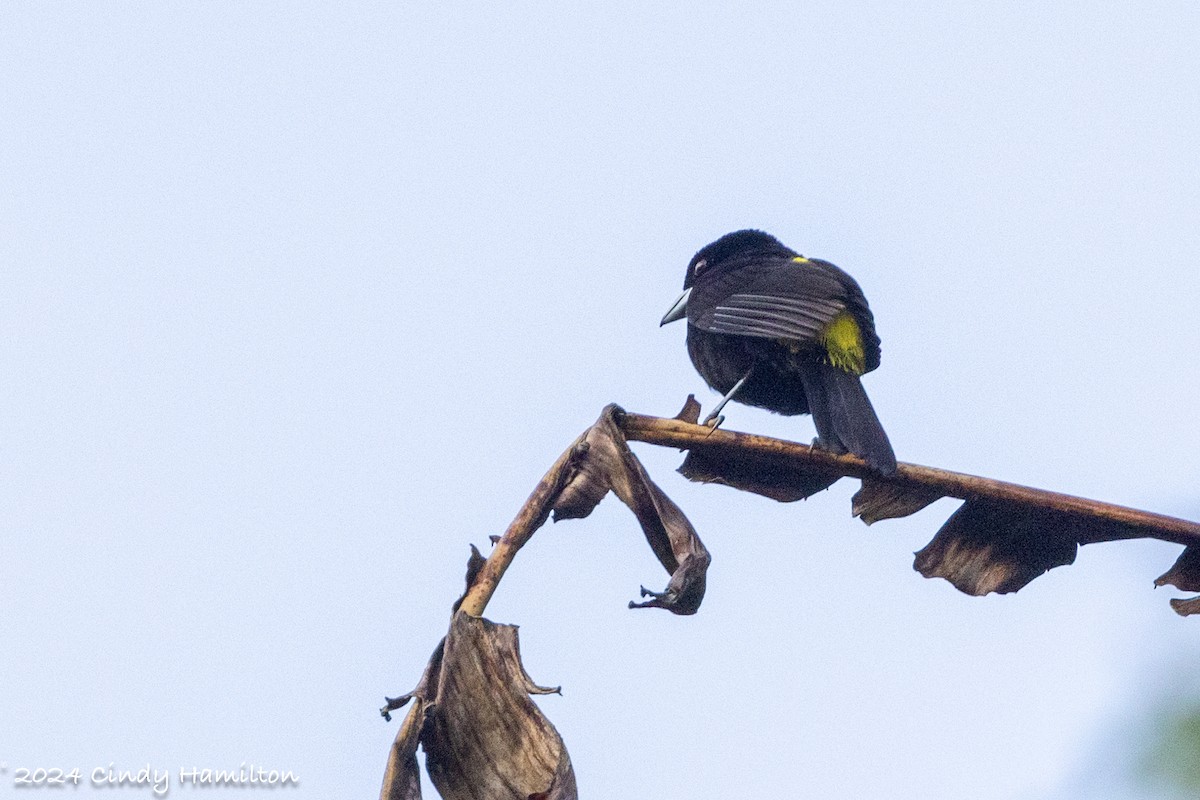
[380,405,709,800]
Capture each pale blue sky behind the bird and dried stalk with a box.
[0,1,1200,800]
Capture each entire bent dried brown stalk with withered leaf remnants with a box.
[380,397,1200,800]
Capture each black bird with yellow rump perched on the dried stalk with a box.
[662,230,896,475]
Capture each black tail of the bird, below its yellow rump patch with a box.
[802,362,896,475]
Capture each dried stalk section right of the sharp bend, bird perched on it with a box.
[617,398,1200,615]
